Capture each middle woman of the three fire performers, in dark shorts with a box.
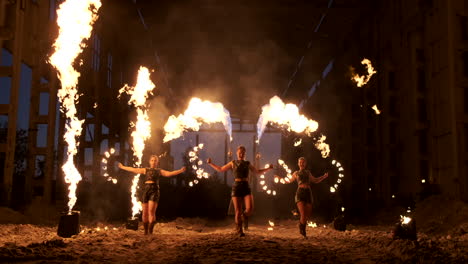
[207,146,273,237]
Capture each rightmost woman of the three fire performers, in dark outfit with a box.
[286,157,328,237]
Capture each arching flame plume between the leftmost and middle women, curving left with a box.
[163,97,232,142]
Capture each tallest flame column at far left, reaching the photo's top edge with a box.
[49,0,101,211]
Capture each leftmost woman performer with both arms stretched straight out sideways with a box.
[119,155,185,235]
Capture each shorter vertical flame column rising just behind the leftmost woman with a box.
[119,67,155,217]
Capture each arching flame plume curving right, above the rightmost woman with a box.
[257,96,318,143]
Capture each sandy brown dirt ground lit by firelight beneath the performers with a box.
[0,195,468,263]
